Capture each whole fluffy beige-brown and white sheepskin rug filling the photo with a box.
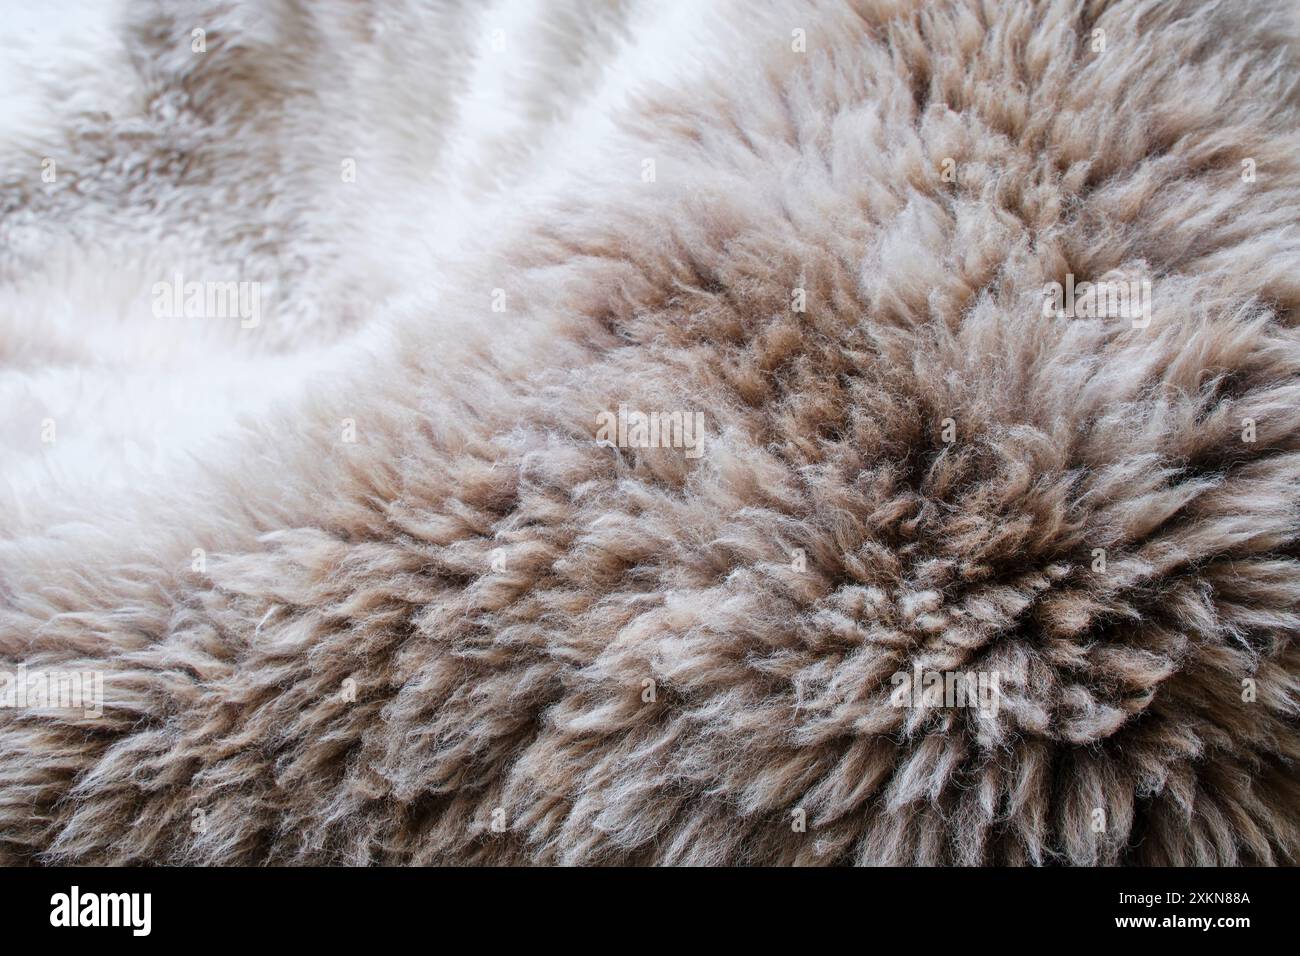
[0,0,1300,865]
